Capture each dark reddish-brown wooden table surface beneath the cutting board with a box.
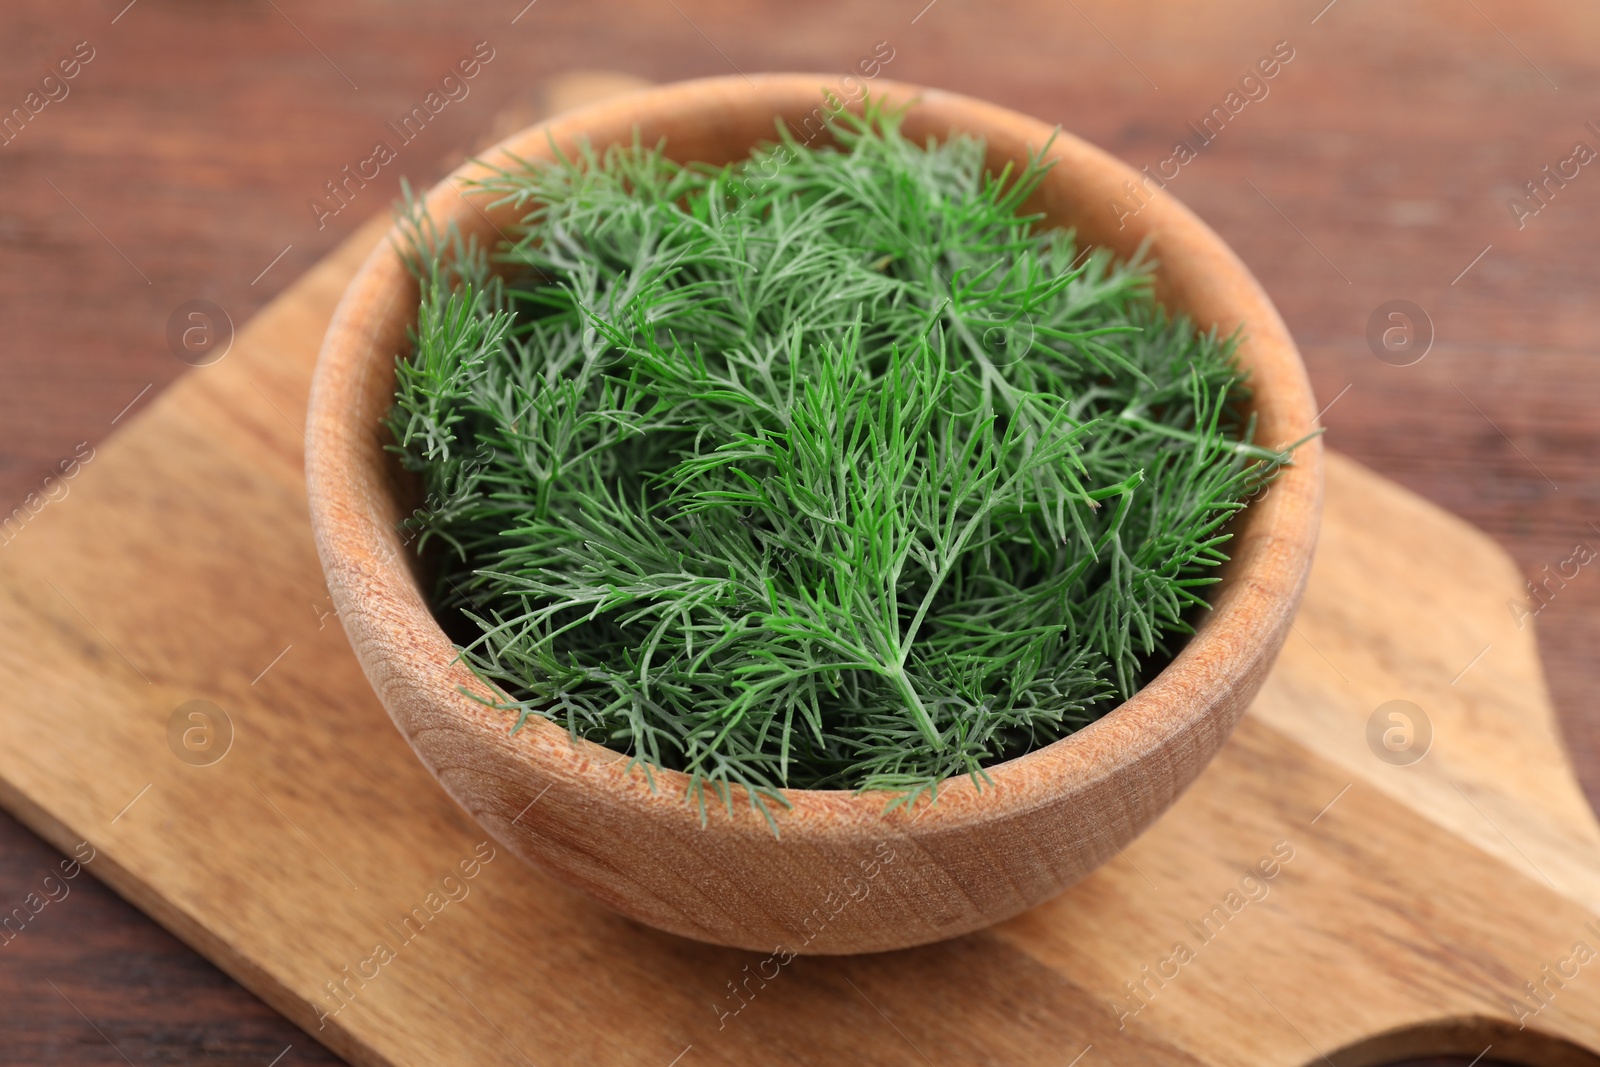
[0,0,1600,1067]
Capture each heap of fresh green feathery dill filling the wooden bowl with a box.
[390,109,1288,817]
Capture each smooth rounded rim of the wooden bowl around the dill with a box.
[306,74,1323,837]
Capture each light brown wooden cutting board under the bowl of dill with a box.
[0,211,1600,1067]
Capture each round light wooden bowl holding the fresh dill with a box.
[306,75,1322,953]
